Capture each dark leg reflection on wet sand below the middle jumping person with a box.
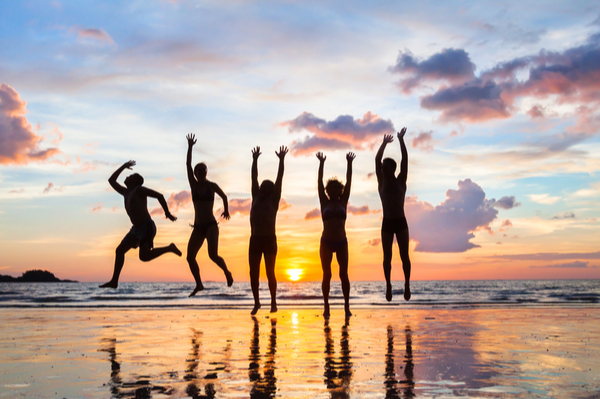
[248,317,277,398]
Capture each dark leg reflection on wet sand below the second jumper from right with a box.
[324,318,352,398]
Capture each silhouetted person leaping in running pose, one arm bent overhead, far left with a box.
[100,161,181,288]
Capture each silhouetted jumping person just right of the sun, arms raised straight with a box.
[316,152,356,317]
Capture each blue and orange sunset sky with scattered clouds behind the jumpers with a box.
[0,0,600,282]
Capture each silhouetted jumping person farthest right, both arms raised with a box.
[375,128,410,301]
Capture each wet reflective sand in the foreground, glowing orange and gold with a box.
[0,307,600,398]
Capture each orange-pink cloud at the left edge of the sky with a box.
[0,83,61,165]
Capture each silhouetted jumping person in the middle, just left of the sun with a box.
[248,146,288,315]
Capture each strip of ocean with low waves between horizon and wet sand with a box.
[0,280,600,309]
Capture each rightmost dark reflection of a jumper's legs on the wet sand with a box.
[384,326,415,398]
